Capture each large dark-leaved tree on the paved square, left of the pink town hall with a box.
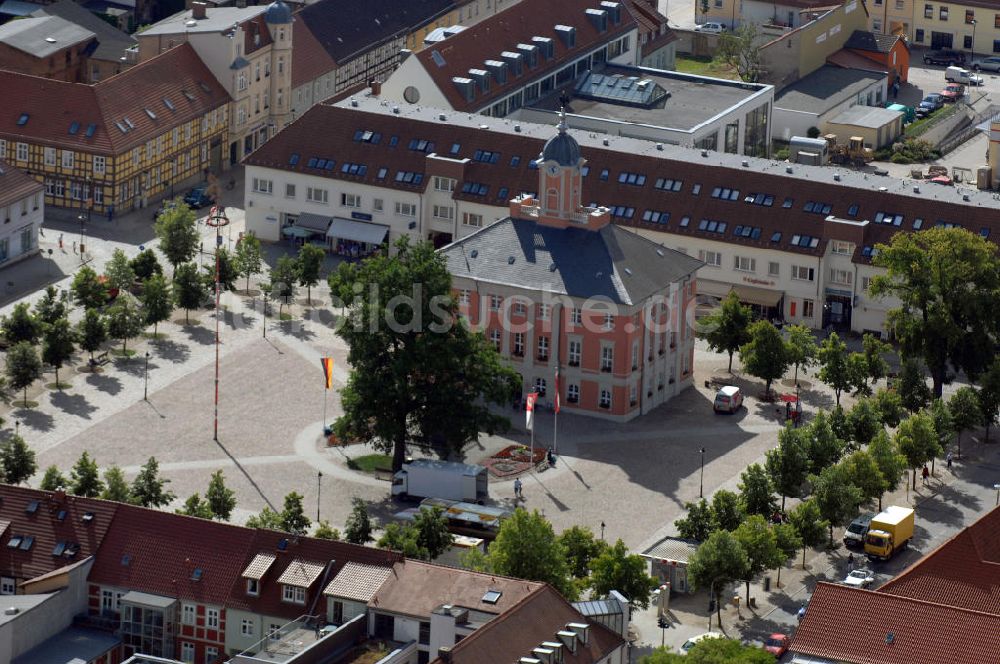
[330,236,520,470]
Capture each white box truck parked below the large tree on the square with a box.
[392,459,489,503]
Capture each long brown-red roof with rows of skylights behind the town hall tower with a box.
[245,101,1000,263]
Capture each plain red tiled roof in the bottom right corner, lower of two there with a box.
[791,583,1000,664]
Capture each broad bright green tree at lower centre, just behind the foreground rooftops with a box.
[489,508,577,601]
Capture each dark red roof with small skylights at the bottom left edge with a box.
[0,484,120,581]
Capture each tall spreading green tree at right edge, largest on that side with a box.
[868,228,997,396]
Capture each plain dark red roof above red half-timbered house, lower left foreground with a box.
[89,505,253,606]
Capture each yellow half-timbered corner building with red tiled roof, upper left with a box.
[0,44,230,218]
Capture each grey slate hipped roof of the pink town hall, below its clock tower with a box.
[441,217,702,305]
